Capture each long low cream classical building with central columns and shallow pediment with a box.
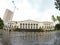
[8,20,54,30]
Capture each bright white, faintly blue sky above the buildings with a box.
[0,0,60,21]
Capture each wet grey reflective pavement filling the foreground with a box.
[0,31,60,45]
